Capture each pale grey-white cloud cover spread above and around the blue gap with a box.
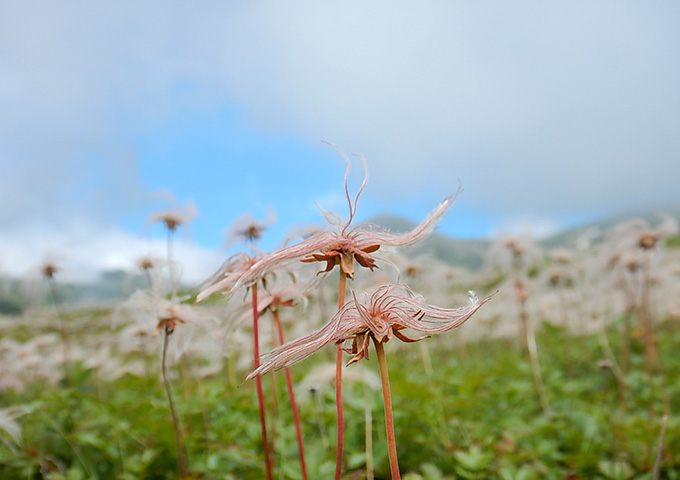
[0,1,680,268]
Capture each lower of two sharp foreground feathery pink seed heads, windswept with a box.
[248,284,490,378]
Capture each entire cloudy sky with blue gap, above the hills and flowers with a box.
[0,1,680,278]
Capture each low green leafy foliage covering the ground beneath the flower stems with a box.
[0,316,680,480]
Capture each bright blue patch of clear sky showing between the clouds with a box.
[131,109,496,249]
